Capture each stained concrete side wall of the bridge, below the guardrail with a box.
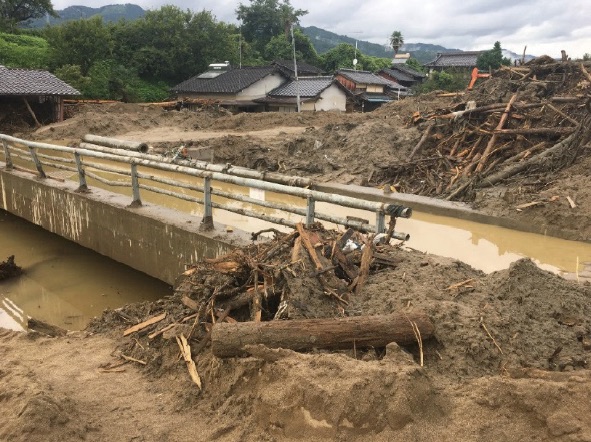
[0,163,247,284]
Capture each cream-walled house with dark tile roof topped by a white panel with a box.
[171,66,289,112]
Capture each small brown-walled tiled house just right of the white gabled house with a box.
[335,69,401,111]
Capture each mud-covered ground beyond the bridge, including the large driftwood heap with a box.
[18,61,591,241]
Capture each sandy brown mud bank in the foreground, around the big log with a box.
[0,240,591,441]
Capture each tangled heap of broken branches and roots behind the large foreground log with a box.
[176,223,408,322]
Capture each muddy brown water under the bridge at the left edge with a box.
[0,209,172,330]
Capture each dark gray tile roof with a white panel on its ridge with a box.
[171,66,278,94]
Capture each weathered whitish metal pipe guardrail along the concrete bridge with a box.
[0,134,412,240]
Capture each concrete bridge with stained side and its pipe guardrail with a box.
[0,134,412,284]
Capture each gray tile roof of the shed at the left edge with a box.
[0,66,80,96]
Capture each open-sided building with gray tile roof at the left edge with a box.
[0,65,80,125]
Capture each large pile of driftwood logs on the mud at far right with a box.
[372,57,591,200]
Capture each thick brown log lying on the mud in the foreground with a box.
[211,313,434,358]
